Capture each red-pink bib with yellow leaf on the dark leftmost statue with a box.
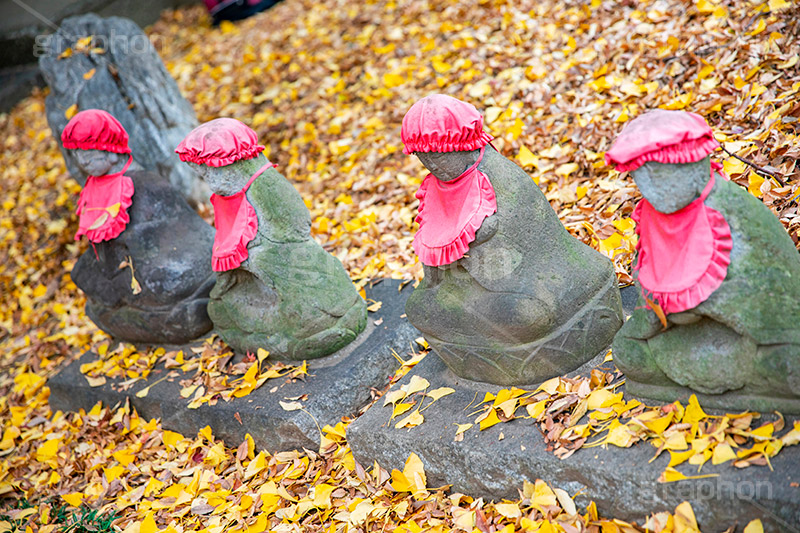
[75,156,133,243]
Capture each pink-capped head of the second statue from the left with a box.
[175,118,267,196]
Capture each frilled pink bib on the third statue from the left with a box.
[413,148,497,266]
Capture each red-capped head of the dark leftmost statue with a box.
[61,109,131,176]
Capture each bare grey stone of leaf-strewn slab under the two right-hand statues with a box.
[347,355,800,532]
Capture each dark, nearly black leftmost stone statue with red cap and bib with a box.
[61,109,215,344]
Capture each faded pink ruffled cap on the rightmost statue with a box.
[605,109,719,172]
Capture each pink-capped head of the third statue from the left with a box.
[400,94,492,181]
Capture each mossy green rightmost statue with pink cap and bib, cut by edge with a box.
[606,110,800,413]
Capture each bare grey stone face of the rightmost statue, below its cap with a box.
[631,157,711,214]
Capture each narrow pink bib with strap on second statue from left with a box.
[211,162,275,272]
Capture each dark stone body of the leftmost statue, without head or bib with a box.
[71,171,216,344]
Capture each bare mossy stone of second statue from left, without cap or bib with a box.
[189,155,367,360]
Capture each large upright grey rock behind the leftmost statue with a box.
[39,14,210,203]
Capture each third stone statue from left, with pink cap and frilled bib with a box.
[402,95,622,385]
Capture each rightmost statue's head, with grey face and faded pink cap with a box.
[605,109,719,213]
